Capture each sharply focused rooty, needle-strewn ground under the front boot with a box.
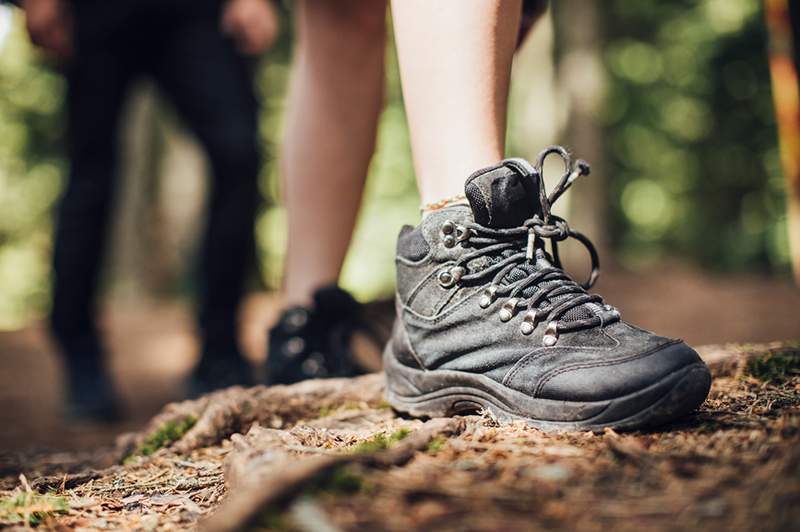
[0,342,800,531]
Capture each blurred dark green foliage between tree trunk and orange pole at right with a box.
[600,0,789,271]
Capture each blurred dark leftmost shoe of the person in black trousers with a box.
[66,357,122,423]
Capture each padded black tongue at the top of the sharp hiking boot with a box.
[464,159,541,229]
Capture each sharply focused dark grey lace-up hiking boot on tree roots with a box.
[384,147,711,430]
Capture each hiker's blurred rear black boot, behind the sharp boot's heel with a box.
[267,286,371,384]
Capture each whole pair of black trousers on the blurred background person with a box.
[51,0,260,362]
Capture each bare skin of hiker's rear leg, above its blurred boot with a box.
[281,0,386,305]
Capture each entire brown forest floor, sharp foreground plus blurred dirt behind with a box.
[0,269,800,530]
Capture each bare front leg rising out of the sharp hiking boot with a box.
[392,0,522,204]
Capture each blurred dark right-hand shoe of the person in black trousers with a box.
[187,345,255,398]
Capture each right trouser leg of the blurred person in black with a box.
[156,13,261,356]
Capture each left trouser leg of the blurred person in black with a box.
[51,48,130,362]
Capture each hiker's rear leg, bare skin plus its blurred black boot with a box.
[267,0,387,383]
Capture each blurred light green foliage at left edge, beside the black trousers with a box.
[0,10,65,329]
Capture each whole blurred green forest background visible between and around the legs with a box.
[0,0,790,329]
